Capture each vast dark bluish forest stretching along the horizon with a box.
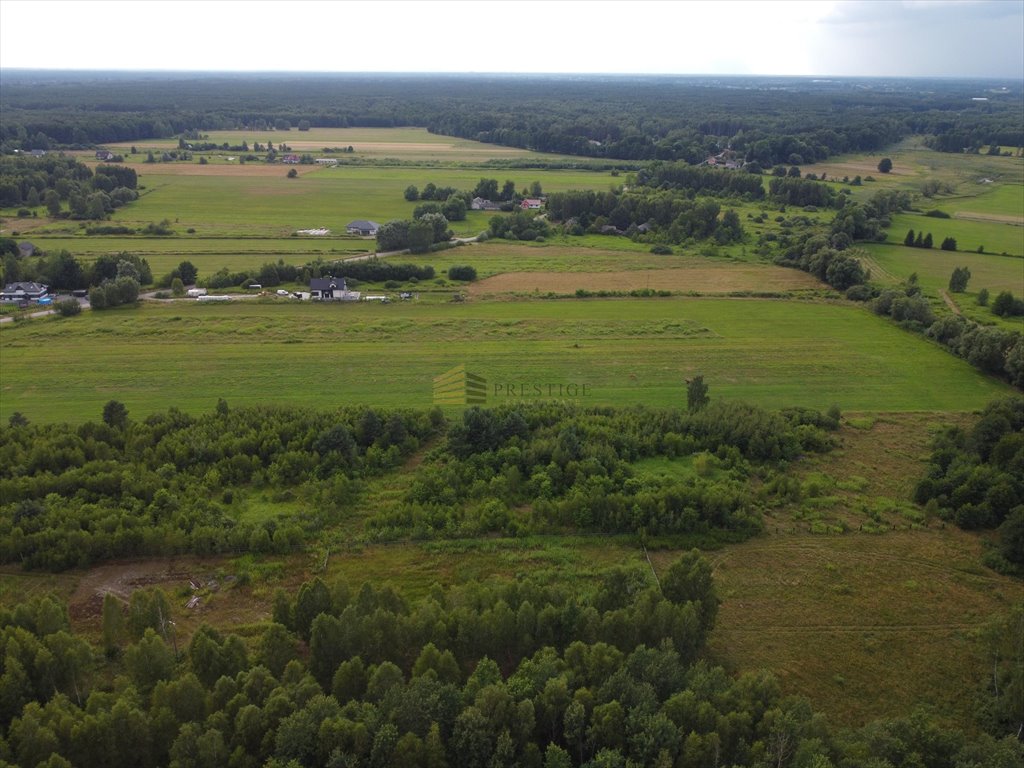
[0,71,1024,167]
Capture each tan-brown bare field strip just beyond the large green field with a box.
[469,263,822,296]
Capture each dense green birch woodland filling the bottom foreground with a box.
[0,565,1024,768]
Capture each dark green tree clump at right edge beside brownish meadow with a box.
[914,397,1024,571]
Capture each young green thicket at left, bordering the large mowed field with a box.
[0,401,441,569]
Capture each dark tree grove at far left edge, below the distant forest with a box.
[0,156,138,219]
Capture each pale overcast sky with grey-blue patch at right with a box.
[0,0,1024,80]
